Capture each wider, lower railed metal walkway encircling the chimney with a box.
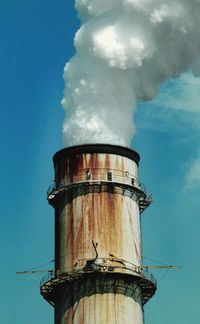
[40,265,157,306]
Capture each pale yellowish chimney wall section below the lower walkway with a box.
[55,278,143,324]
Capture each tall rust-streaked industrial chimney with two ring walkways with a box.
[41,144,156,324]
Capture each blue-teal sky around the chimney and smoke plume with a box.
[0,0,200,324]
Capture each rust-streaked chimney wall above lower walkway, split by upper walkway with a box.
[56,154,141,270]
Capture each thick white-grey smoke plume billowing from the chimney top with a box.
[62,0,200,146]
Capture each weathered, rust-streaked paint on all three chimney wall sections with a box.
[55,146,143,324]
